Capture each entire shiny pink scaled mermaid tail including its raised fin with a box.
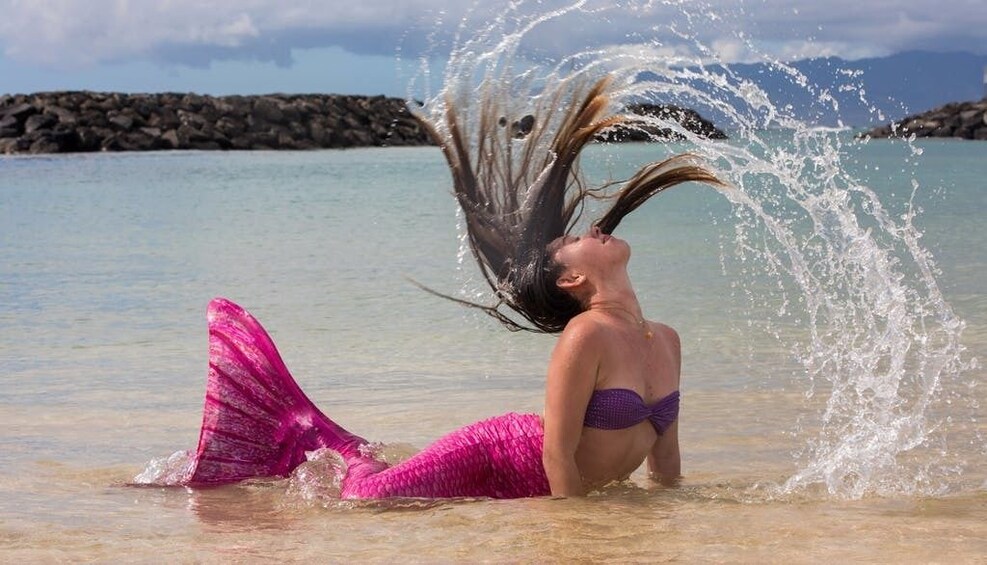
[182,298,549,498]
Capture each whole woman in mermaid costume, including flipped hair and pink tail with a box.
[179,80,719,498]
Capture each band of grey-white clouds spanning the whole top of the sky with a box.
[0,0,987,68]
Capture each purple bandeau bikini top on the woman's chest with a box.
[583,388,679,435]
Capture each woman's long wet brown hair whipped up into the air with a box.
[418,74,721,333]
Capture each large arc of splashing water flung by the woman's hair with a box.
[408,1,976,498]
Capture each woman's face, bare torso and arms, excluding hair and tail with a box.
[543,227,681,496]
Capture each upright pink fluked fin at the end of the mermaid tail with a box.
[183,298,367,486]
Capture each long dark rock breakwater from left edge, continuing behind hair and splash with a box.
[0,91,726,155]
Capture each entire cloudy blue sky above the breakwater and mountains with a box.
[0,0,987,96]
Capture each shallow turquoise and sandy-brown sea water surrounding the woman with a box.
[0,132,987,563]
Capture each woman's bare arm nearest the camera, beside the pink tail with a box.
[542,318,600,496]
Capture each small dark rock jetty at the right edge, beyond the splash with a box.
[861,98,987,140]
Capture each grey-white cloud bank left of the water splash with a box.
[0,0,456,67]
